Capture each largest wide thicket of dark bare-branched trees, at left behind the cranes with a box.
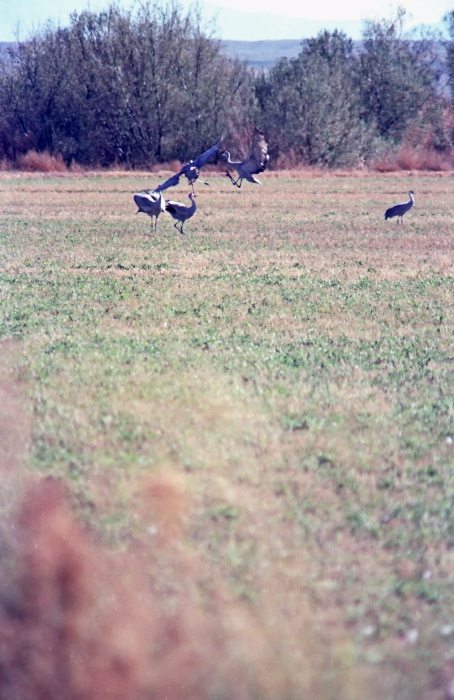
[0,2,254,166]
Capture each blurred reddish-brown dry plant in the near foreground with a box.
[0,479,306,700]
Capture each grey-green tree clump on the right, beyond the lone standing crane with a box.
[256,10,452,166]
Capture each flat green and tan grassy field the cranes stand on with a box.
[0,172,454,700]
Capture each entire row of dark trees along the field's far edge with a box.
[0,0,454,168]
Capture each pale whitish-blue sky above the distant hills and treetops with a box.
[0,0,454,41]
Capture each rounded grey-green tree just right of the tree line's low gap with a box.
[256,31,371,166]
